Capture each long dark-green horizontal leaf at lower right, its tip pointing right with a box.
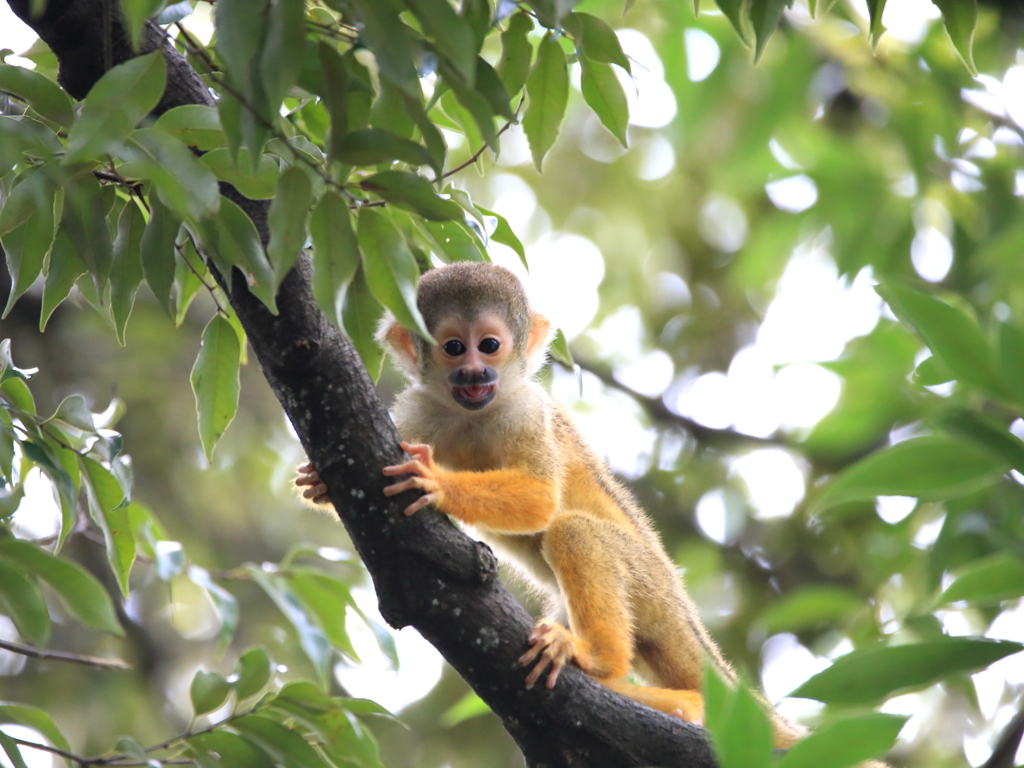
[790,637,1024,705]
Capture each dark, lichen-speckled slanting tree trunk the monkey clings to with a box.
[2,0,715,768]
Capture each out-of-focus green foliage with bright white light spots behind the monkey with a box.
[0,0,1024,768]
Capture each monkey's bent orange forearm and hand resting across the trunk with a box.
[384,442,558,534]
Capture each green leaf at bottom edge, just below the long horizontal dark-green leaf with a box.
[778,713,909,768]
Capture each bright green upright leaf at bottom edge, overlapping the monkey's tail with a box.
[705,664,772,768]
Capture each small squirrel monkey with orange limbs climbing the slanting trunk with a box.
[296,262,803,746]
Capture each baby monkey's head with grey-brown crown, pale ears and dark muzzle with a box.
[379,261,551,411]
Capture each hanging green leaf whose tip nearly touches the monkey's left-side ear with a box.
[356,208,432,343]
